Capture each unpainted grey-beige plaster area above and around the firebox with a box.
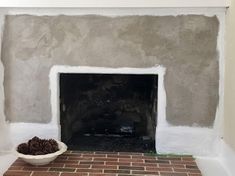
[1,15,219,127]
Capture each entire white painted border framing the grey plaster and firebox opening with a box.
[0,8,225,156]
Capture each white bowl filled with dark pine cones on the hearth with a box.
[16,136,67,166]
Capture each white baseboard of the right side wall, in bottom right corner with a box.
[219,141,235,176]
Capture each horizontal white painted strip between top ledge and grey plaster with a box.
[0,7,226,17]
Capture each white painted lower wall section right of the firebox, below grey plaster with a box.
[156,126,220,156]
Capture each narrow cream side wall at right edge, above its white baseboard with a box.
[224,0,235,151]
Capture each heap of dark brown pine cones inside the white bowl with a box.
[17,136,59,155]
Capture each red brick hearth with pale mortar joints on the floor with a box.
[4,151,201,176]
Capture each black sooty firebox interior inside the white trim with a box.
[60,73,158,152]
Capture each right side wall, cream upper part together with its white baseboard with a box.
[219,0,235,176]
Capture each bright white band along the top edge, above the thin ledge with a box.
[0,0,229,8]
